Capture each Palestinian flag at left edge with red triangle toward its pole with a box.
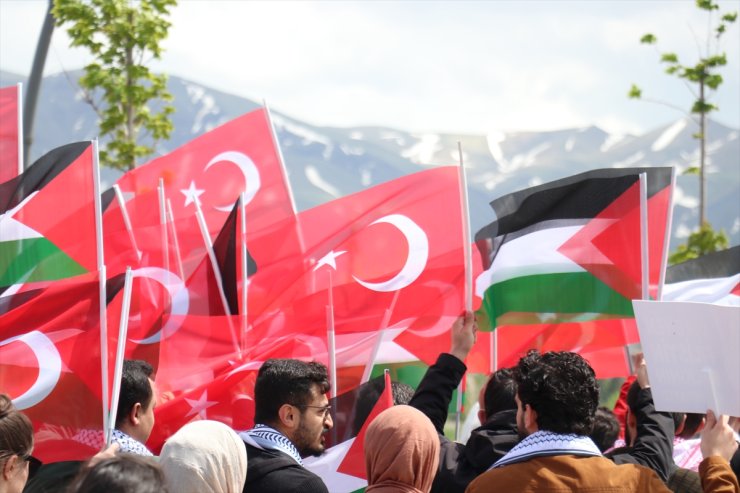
[0,142,96,292]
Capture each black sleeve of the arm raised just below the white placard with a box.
[609,388,675,481]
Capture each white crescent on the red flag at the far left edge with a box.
[0,330,62,410]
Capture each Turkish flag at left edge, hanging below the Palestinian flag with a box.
[0,273,111,462]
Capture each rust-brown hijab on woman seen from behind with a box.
[365,406,439,493]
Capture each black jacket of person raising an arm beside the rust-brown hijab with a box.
[409,353,519,493]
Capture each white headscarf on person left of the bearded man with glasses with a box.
[160,421,247,493]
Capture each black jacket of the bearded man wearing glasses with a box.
[244,443,329,493]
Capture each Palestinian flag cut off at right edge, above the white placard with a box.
[663,245,740,306]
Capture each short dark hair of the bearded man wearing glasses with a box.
[254,359,329,424]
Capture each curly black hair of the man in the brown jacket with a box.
[514,350,599,436]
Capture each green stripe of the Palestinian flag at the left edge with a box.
[0,238,87,286]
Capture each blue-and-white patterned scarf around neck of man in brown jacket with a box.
[491,430,601,469]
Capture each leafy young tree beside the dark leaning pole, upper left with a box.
[53,0,176,170]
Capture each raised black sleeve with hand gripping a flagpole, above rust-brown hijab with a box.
[409,353,467,435]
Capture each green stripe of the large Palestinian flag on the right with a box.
[479,272,633,330]
